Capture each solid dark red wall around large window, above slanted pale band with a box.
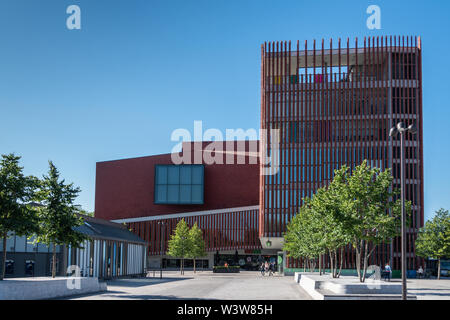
[95,142,259,220]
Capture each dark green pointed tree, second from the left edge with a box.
[35,161,86,278]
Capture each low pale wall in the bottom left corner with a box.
[0,277,107,300]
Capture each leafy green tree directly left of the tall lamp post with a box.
[330,160,411,282]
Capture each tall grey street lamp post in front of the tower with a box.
[389,122,417,300]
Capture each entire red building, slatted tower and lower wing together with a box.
[95,37,424,271]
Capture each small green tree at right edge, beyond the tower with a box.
[416,208,450,279]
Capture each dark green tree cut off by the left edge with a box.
[0,154,39,280]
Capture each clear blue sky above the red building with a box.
[0,0,450,218]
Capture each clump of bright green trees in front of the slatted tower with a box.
[284,160,411,282]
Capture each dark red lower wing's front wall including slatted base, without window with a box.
[95,141,260,254]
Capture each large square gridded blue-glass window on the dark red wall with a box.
[155,164,204,204]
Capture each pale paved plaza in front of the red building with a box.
[65,271,450,300]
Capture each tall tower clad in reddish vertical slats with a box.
[259,36,424,269]
